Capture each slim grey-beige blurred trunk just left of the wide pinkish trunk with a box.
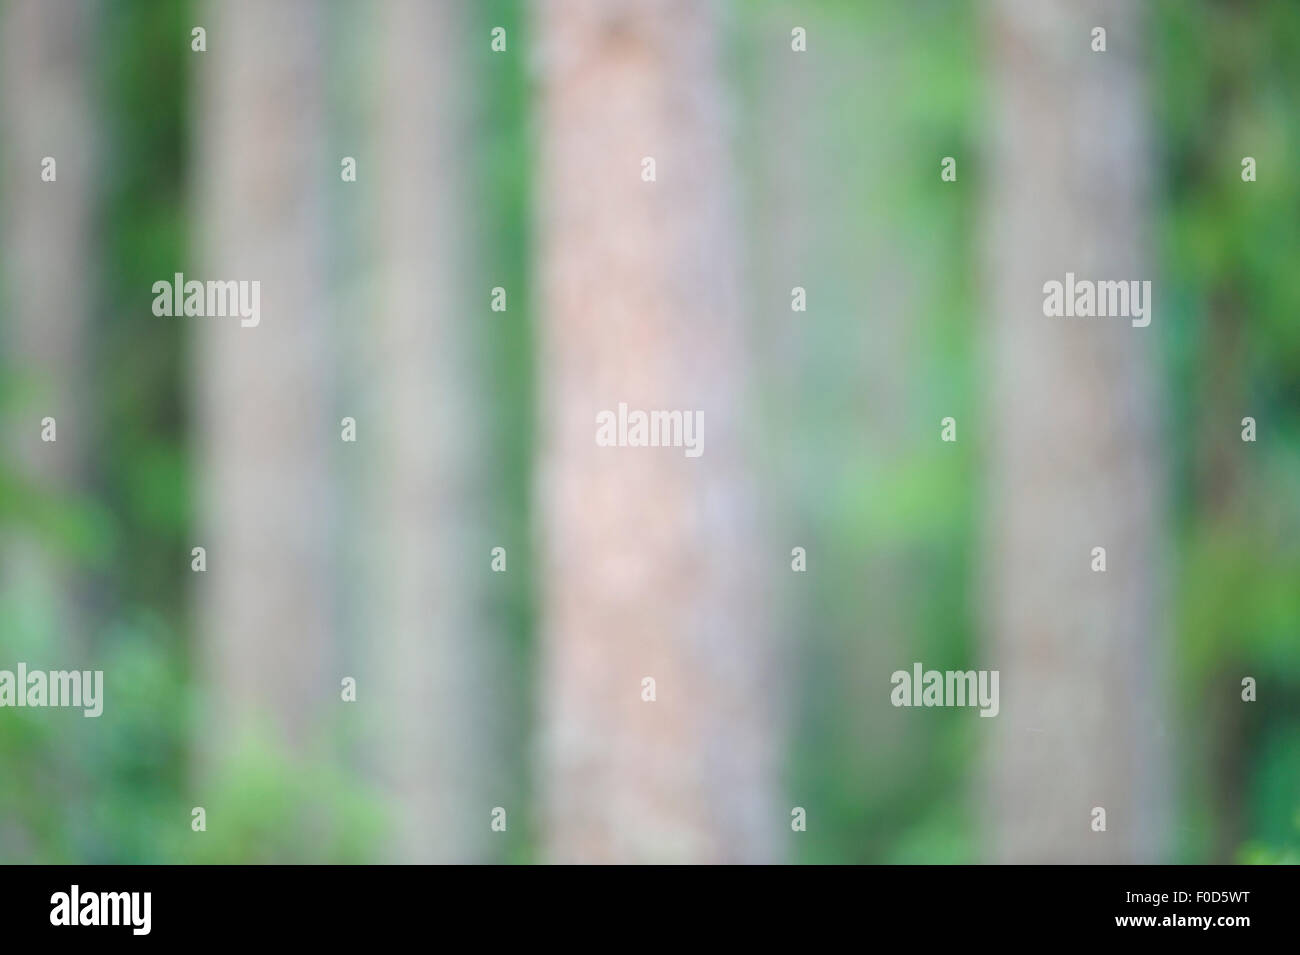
[359,0,496,863]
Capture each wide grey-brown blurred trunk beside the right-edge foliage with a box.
[983,0,1169,863]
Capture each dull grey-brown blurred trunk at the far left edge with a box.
[0,0,98,654]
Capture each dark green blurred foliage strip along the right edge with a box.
[1151,0,1300,861]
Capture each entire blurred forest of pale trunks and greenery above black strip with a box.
[0,0,1300,863]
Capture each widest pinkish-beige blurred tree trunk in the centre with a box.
[534,0,789,861]
